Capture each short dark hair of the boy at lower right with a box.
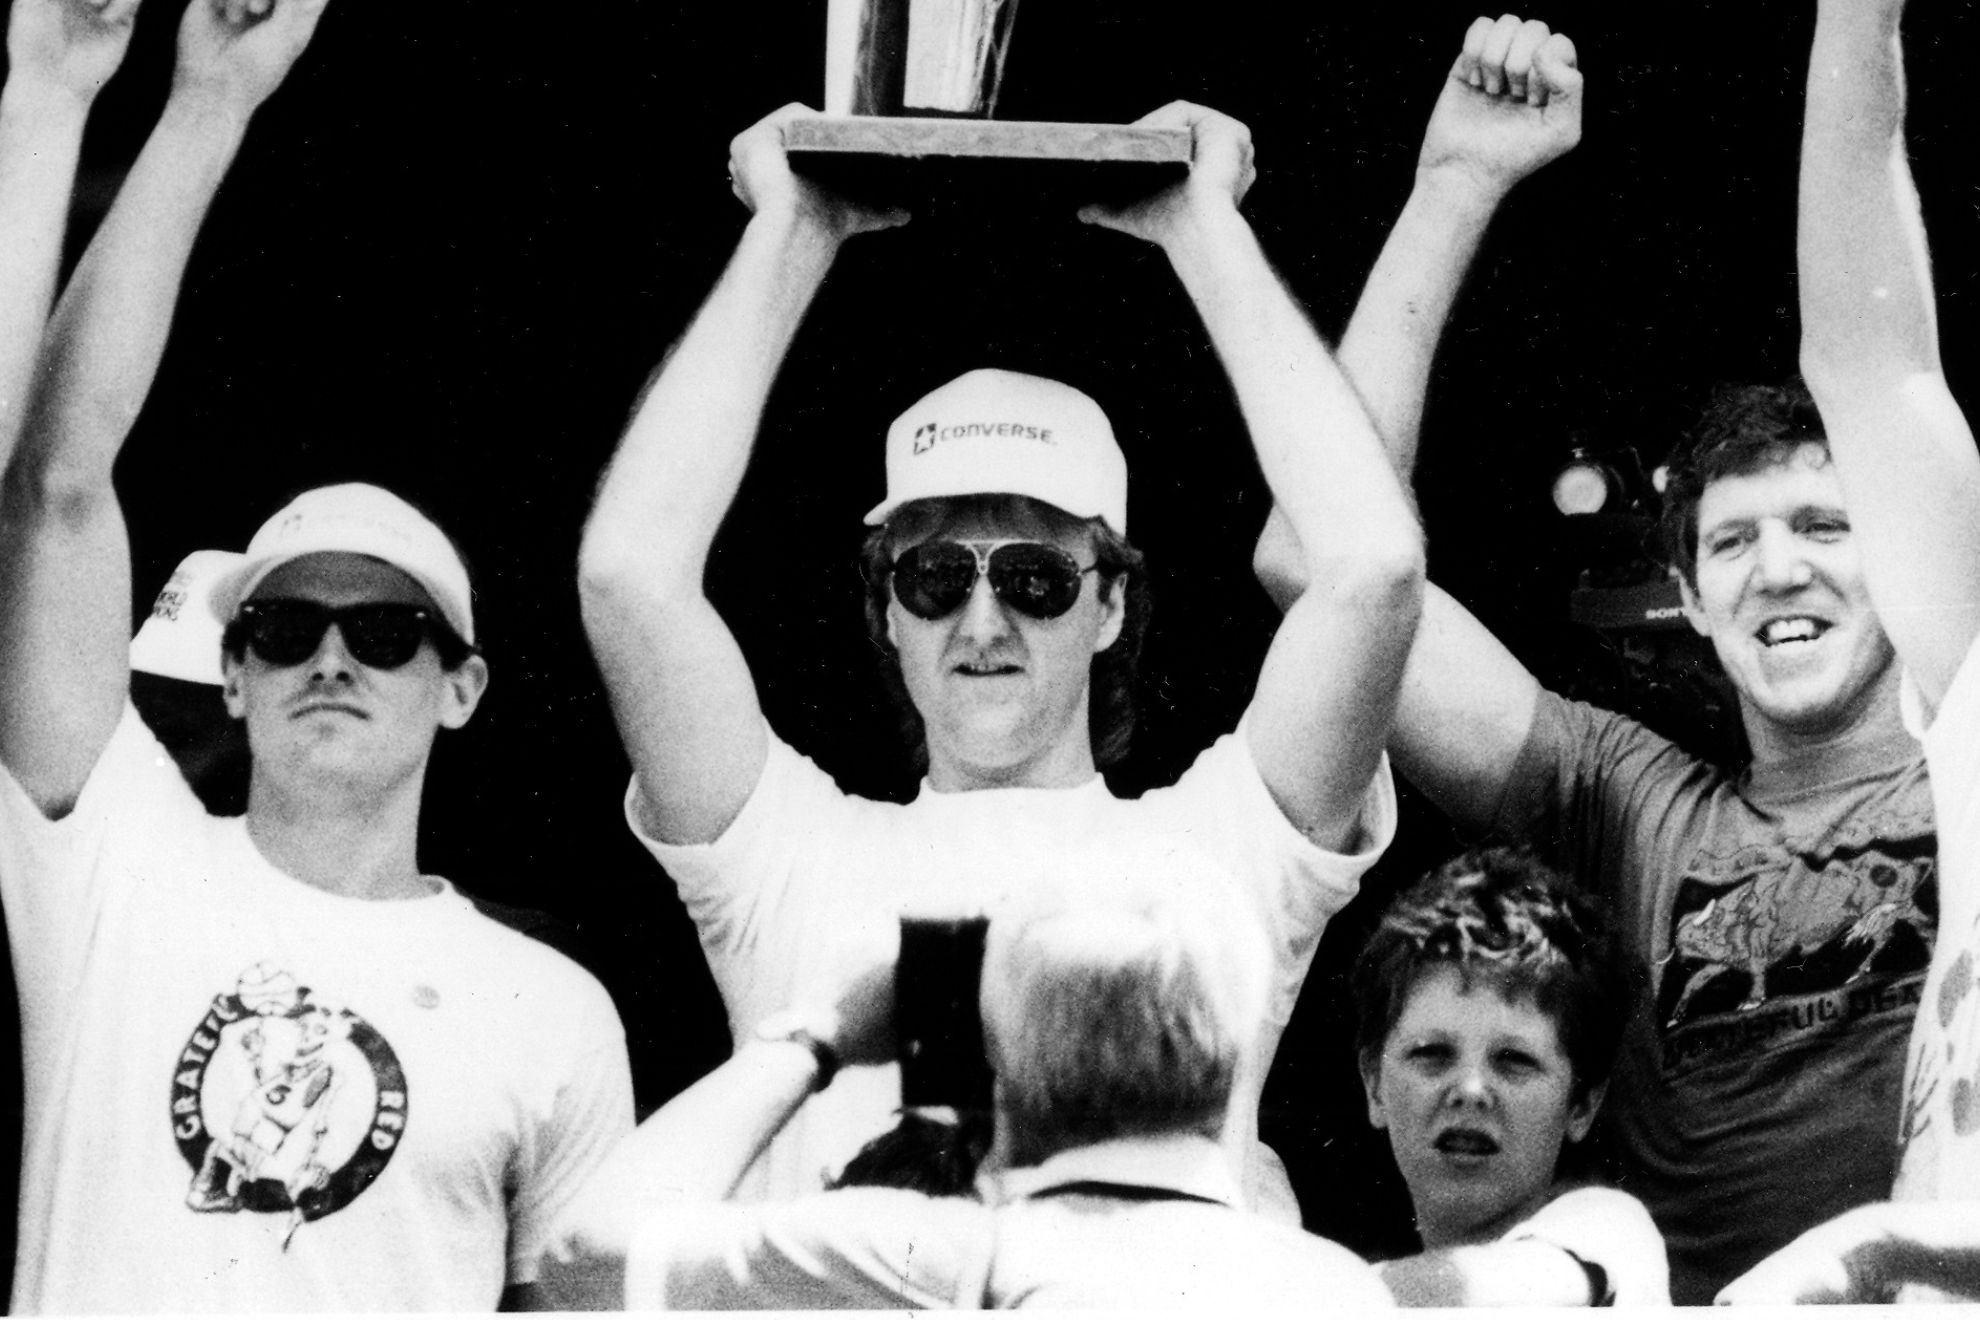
[1348,847,1634,1098]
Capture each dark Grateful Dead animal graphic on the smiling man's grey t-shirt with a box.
[1657,831,1938,1073]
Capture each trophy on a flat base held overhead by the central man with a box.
[784,0,1190,206]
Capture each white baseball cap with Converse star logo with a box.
[865,368,1127,536]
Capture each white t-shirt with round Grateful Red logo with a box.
[0,707,632,1312]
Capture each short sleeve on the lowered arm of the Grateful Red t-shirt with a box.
[509,1001,634,1282]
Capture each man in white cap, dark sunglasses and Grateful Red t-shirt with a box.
[0,0,632,1314]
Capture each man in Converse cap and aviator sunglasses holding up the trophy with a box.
[580,105,1424,1217]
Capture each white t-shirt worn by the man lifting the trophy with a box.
[626,726,1396,1217]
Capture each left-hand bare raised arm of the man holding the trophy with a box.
[578,105,907,843]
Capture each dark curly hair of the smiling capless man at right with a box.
[1659,378,1830,586]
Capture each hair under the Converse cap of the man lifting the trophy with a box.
[859,495,1154,770]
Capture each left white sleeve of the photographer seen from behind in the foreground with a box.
[626,1187,994,1310]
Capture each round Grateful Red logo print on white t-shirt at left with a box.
[172,962,406,1249]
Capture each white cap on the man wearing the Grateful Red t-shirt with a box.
[212,481,475,645]
